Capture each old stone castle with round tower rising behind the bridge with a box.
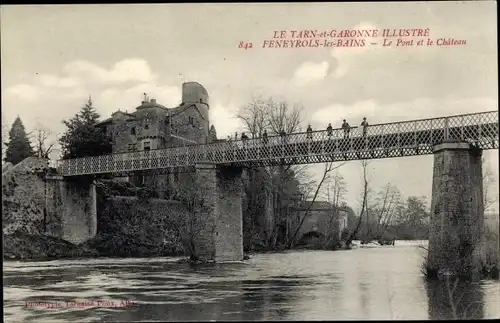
[97,82,217,195]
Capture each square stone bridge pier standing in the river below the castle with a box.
[192,163,243,262]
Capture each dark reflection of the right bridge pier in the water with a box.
[427,279,484,320]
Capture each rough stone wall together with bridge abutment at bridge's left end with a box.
[2,157,97,243]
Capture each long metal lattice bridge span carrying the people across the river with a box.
[58,111,498,176]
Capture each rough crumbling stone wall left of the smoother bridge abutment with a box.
[2,157,47,234]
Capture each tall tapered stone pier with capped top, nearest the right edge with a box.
[427,142,484,277]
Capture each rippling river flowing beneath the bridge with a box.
[4,241,500,322]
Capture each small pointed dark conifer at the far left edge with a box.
[4,116,34,165]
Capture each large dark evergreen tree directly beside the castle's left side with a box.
[59,98,111,159]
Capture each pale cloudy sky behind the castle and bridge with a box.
[0,1,498,213]
